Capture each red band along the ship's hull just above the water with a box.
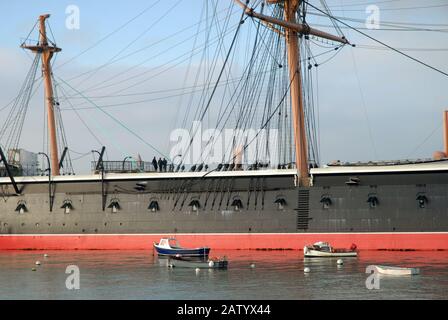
[0,232,448,250]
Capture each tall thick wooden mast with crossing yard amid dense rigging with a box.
[235,0,349,186]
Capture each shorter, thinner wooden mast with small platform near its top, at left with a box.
[22,14,61,176]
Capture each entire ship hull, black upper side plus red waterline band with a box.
[0,164,448,250]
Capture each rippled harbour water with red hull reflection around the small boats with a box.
[0,250,448,300]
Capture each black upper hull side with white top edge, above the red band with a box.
[0,166,448,234]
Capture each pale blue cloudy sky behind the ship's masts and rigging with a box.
[0,0,448,173]
